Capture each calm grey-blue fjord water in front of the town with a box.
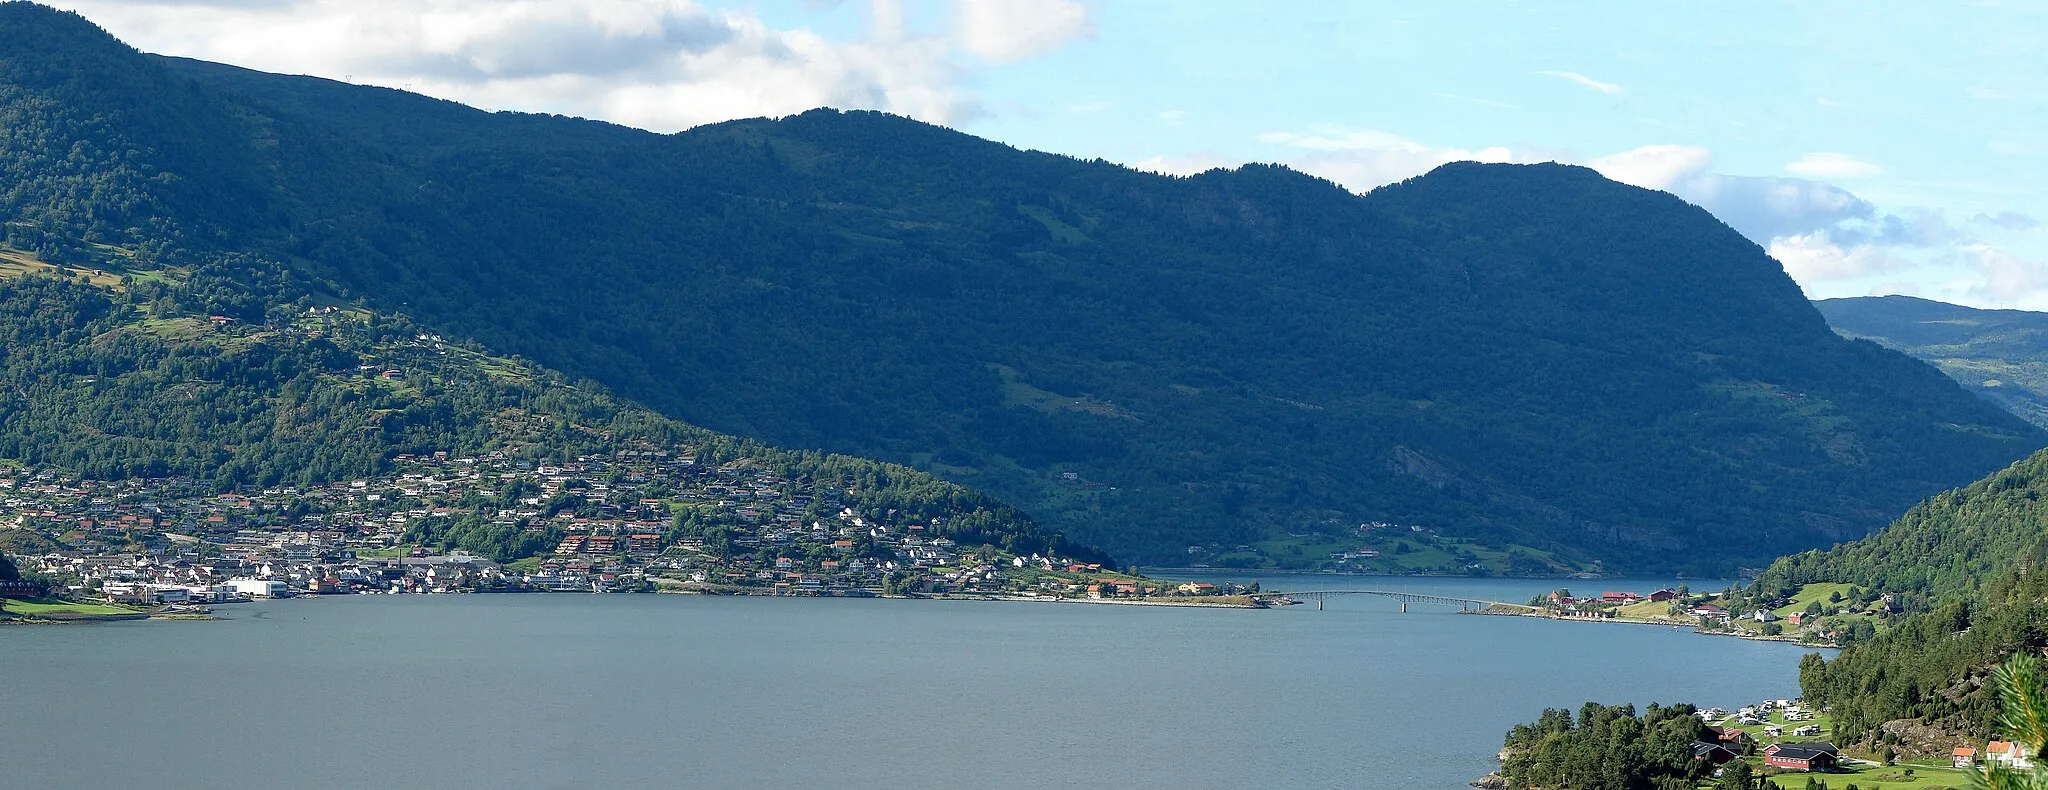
[0,577,1800,788]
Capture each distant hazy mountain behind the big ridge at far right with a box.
[1815,297,2048,428]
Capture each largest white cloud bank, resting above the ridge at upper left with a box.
[48,0,1087,131]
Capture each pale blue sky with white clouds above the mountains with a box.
[53,0,2048,309]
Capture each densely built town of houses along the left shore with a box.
[0,450,1253,606]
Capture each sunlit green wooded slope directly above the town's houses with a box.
[0,266,1102,571]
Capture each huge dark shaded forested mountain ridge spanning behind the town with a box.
[0,2,2048,571]
